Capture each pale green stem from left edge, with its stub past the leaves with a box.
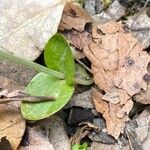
[0,47,93,85]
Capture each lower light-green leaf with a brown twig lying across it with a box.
[21,73,74,120]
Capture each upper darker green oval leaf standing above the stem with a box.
[44,33,75,84]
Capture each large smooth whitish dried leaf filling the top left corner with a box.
[0,0,65,60]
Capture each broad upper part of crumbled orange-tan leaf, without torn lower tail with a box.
[84,22,150,96]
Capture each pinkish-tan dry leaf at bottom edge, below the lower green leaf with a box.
[19,126,54,150]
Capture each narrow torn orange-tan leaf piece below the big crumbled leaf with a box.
[92,89,128,139]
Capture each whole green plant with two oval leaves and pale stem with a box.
[0,34,93,120]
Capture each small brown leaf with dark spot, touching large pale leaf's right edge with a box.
[59,3,92,32]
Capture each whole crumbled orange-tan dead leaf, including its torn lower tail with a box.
[83,21,150,138]
